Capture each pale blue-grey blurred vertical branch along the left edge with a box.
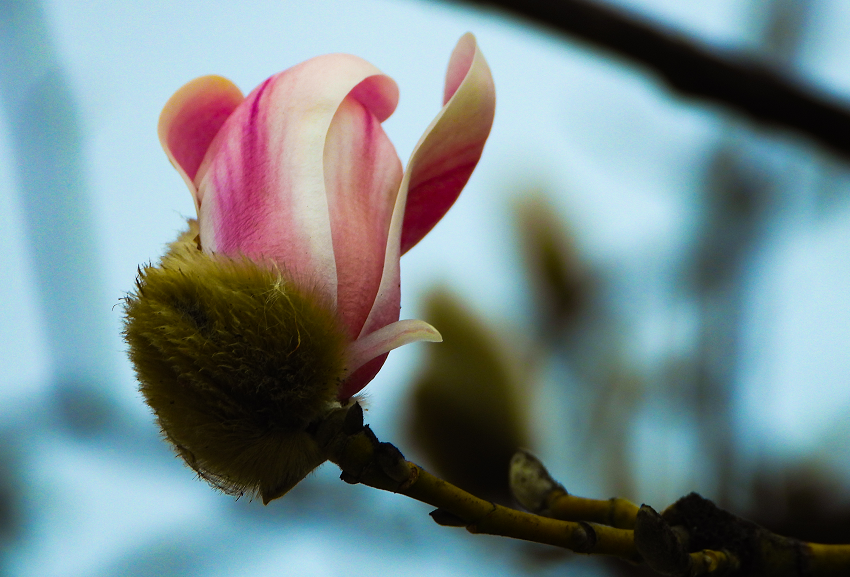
[0,1,117,434]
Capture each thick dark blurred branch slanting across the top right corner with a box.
[458,0,850,158]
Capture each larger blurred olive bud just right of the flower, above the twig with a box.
[408,289,532,503]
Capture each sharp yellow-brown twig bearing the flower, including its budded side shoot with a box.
[311,403,850,577]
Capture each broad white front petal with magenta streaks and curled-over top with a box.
[196,54,397,303]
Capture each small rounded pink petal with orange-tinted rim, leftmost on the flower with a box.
[158,76,245,208]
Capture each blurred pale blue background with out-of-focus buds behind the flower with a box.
[0,0,850,577]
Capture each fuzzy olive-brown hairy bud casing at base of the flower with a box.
[124,221,347,503]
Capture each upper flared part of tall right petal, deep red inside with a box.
[401,33,496,254]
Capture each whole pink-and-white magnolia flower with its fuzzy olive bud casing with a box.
[125,34,495,502]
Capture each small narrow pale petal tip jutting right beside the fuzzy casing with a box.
[339,320,443,399]
